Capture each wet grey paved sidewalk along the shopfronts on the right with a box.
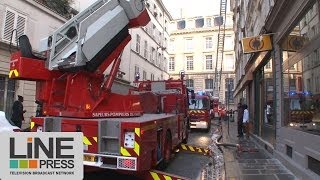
[221,121,296,180]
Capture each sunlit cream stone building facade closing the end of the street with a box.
[168,13,235,108]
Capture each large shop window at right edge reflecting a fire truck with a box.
[282,4,320,135]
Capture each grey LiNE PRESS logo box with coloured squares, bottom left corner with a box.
[0,132,83,180]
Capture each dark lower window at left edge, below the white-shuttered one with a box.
[0,76,16,119]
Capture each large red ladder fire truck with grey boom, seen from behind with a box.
[9,0,188,176]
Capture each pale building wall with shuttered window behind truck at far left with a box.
[0,0,66,127]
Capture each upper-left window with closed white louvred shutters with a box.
[2,8,27,44]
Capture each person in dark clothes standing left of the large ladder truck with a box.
[11,95,26,128]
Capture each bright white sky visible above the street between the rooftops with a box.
[75,0,220,19]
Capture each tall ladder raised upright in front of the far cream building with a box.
[213,0,227,98]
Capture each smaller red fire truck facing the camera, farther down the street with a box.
[188,93,211,132]
